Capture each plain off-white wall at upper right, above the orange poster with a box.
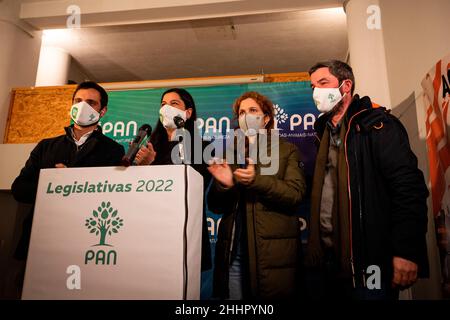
[380,0,450,106]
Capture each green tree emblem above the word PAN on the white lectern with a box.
[85,201,123,246]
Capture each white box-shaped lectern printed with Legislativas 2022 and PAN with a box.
[22,165,203,300]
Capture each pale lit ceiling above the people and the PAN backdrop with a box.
[39,8,348,82]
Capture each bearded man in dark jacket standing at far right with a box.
[306,60,428,299]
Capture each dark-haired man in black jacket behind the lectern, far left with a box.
[11,81,124,260]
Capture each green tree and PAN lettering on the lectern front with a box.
[84,201,123,265]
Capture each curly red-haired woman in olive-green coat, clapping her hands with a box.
[208,92,306,299]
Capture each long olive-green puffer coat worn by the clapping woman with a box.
[208,139,306,299]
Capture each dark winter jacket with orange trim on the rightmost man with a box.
[312,96,429,283]
